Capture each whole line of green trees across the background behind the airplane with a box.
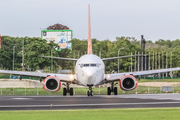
[0,36,180,73]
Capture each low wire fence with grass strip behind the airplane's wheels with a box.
[0,86,180,95]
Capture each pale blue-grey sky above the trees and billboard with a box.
[0,0,180,41]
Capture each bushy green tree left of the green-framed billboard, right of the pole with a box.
[25,38,58,71]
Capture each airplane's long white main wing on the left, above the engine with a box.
[0,70,74,82]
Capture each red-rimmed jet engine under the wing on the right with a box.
[119,75,137,91]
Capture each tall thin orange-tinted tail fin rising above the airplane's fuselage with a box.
[87,4,92,54]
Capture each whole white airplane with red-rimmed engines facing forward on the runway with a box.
[0,5,180,96]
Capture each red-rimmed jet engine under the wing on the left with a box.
[43,76,61,92]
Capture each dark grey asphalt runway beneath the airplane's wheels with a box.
[0,94,180,110]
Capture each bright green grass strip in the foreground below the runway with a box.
[0,108,180,120]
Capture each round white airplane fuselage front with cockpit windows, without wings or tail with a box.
[75,54,105,86]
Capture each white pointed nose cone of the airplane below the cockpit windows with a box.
[84,70,96,85]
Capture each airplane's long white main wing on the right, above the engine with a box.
[105,67,180,82]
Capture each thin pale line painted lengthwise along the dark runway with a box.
[0,102,180,108]
